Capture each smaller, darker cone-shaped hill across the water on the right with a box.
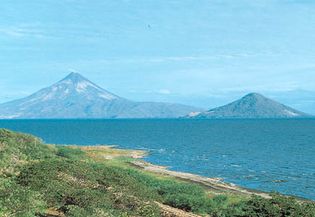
[186,93,310,119]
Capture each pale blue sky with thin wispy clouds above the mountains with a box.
[0,0,315,114]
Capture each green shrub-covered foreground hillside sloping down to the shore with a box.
[0,129,315,217]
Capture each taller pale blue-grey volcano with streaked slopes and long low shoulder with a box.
[0,73,201,119]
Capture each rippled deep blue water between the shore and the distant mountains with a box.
[0,119,315,200]
